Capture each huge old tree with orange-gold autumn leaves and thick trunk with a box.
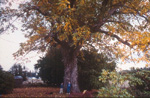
[4,0,150,92]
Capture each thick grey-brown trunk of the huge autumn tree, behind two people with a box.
[62,48,80,93]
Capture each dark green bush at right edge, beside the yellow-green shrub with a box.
[127,68,150,97]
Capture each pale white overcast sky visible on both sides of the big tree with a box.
[0,0,145,71]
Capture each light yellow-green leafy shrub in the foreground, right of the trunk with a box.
[98,70,133,98]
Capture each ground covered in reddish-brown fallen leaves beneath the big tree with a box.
[1,87,98,98]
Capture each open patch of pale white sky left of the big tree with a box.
[0,30,43,71]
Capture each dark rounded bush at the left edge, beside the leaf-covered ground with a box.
[0,70,14,94]
